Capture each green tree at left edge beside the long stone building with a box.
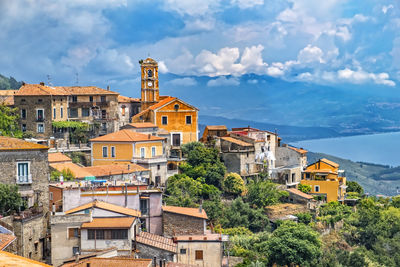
[0,104,22,138]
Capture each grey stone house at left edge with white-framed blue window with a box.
[0,136,49,261]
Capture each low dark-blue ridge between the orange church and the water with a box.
[199,115,344,143]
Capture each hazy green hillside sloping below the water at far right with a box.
[307,152,400,196]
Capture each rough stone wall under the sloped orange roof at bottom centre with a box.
[162,211,205,237]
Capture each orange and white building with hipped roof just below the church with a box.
[90,130,167,185]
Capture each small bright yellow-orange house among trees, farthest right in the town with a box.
[300,158,346,202]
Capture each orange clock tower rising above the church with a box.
[140,58,160,111]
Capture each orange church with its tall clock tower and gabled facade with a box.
[132,58,198,147]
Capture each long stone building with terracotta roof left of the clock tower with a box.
[10,83,119,146]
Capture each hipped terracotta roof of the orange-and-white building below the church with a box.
[90,129,164,142]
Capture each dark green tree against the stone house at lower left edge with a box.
[0,184,23,216]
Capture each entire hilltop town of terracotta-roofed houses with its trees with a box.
[0,58,400,267]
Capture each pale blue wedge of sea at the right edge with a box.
[291,132,400,167]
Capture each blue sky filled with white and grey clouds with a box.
[0,0,400,99]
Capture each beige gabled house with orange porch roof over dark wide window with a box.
[51,201,141,266]
